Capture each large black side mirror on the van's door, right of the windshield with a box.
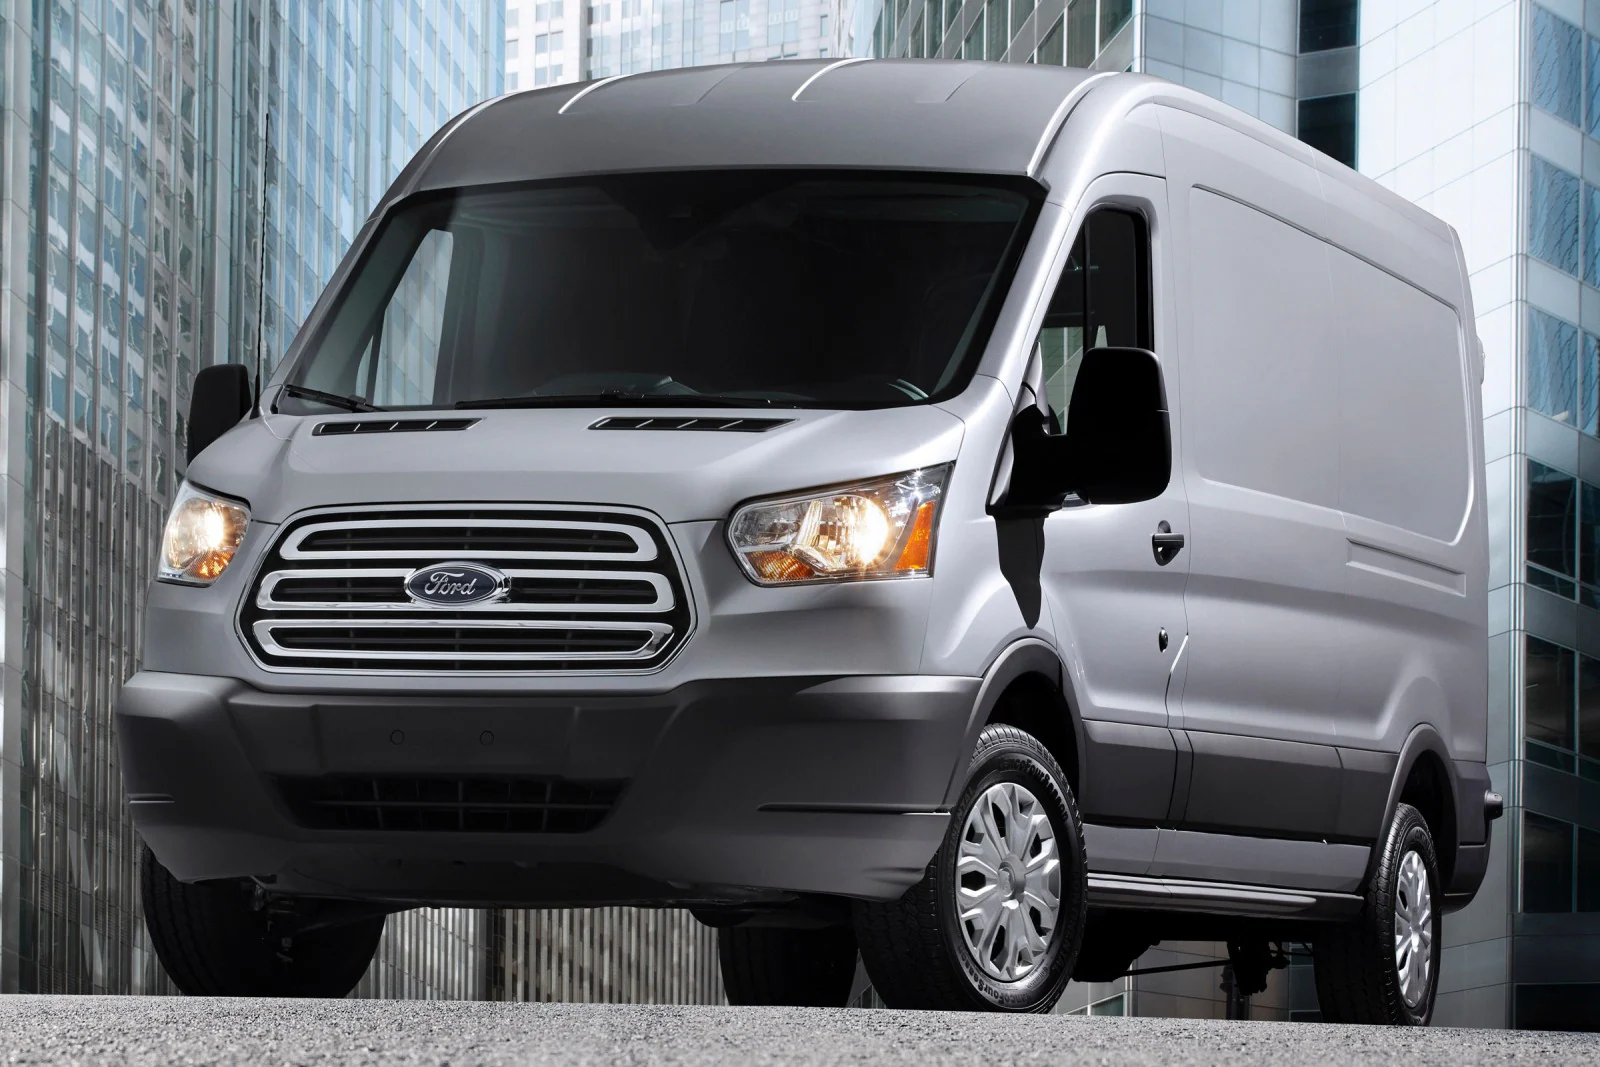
[995,349,1173,517]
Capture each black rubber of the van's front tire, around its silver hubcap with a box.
[856,725,1088,1013]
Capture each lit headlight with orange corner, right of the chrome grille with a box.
[728,464,950,585]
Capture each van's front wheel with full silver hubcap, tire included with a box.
[856,725,1088,1013]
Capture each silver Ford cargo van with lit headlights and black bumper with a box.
[117,61,1501,1024]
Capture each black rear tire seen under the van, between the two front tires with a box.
[717,926,856,1008]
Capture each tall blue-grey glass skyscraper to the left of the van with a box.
[0,0,506,995]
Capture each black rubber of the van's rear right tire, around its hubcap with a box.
[1312,805,1443,1027]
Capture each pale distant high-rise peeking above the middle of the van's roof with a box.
[506,0,850,90]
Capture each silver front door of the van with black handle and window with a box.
[1035,183,1189,851]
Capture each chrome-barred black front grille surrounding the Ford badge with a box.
[240,507,690,673]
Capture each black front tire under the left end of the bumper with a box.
[139,848,384,997]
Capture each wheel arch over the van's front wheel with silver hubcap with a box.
[944,638,1083,808]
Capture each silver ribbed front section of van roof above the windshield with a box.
[402,59,1093,192]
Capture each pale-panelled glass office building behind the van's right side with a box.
[856,0,1600,1027]
